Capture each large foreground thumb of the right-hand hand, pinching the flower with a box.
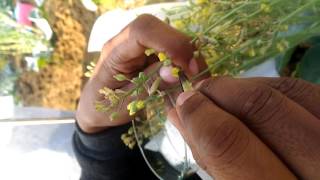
[173,91,294,179]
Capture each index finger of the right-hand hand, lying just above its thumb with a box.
[198,77,320,179]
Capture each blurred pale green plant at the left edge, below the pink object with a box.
[0,5,50,95]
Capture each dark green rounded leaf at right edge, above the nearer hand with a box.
[297,44,320,84]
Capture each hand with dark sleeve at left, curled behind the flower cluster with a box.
[76,15,204,133]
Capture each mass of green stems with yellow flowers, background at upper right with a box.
[168,0,319,75]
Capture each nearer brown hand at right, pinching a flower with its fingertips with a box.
[169,77,320,179]
